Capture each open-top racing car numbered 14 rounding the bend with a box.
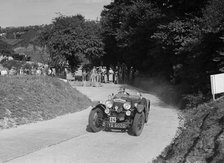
[89,88,150,136]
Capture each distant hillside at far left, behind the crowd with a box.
[0,26,49,63]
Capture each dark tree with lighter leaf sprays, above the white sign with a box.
[153,0,224,93]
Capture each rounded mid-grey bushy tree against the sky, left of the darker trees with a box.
[40,15,103,71]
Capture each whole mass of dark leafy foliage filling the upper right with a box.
[101,0,224,94]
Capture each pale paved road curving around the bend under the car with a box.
[0,84,178,163]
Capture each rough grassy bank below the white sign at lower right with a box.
[154,98,224,163]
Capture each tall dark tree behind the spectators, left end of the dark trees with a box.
[101,0,162,74]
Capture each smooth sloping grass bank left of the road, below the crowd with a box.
[0,76,91,129]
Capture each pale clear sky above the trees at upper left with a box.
[0,0,111,28]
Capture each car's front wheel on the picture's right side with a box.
[131,112,145,136]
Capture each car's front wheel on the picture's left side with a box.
[89,108,104,132]
